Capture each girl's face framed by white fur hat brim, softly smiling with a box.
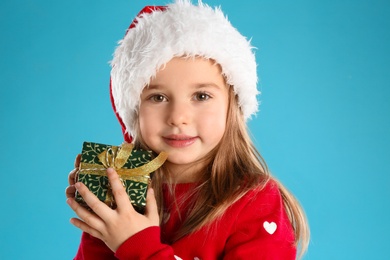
[139,58,229,177]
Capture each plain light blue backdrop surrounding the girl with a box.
[0,0,390,259]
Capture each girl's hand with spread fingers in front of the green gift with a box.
[67,168,159,252]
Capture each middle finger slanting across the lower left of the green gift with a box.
[75,182,112,220]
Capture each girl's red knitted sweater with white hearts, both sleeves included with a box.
[75,181,296,260]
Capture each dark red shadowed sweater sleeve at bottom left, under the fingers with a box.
[74,232,116,260]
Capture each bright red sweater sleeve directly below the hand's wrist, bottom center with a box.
[115,226,176,260]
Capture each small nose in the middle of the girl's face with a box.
[167,101,192,126]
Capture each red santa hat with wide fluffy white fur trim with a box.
[110,0,259,142]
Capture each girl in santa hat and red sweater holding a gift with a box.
[66,0,309,259]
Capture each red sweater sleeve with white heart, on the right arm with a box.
[224,181,296,260]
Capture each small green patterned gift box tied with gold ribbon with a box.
[75,142,168,213]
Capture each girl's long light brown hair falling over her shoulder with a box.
[136,86,310,257]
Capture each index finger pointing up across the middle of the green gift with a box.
[107,168,132,211]
